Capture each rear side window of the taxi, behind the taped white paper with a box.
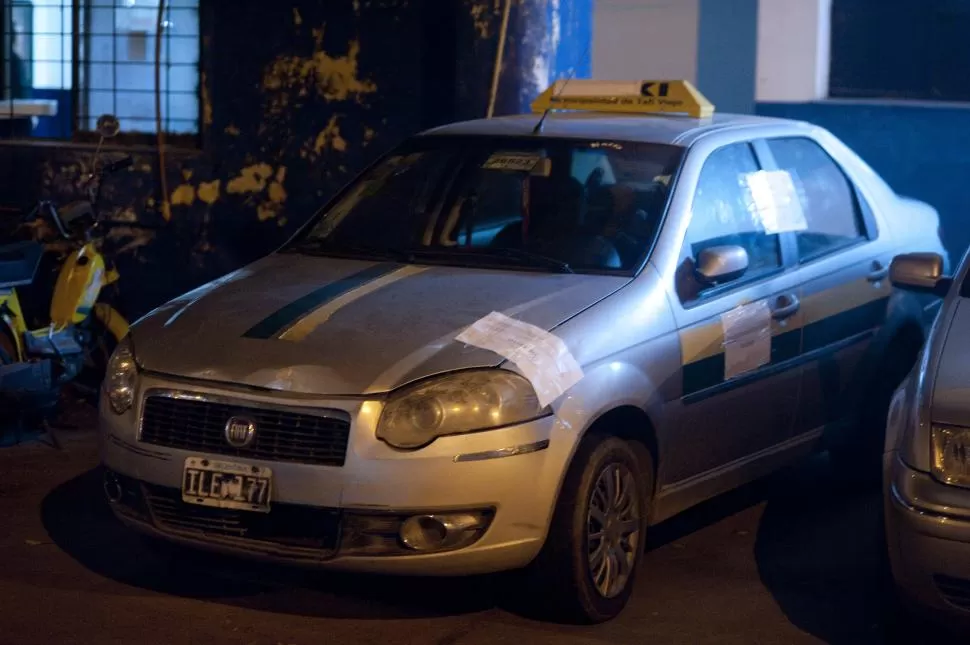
[768,137,865,262]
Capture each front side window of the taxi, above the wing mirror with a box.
[684,143,782,300]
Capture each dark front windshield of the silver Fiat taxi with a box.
[284,136,683,274]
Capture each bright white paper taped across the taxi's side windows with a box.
[742,170,808,235]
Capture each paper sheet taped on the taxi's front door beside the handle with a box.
[721,300,771,379]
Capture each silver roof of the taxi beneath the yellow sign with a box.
[421,112,809,146]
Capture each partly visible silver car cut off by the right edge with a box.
[883,248,970,618]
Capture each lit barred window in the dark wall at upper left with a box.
[0,0,202,140]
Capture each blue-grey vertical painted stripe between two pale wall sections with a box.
[697,0,758,114]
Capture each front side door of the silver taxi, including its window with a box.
[662,142,802,485]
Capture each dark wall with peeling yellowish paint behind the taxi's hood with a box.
[0,0,591,318]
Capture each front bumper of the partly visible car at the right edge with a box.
[884,453,970,619]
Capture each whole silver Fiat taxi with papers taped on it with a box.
[100,81,943,621]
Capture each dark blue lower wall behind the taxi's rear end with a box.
[757,101,970,260]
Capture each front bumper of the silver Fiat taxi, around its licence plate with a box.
[100,377,573,575]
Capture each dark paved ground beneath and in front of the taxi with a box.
[0,426,956,645]
